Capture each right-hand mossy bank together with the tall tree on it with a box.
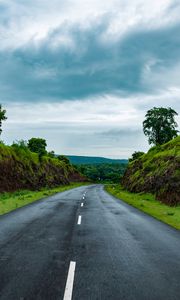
[121,107,180,206]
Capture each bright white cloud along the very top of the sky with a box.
[0,0,179,49]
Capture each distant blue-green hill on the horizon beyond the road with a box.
[66,155,128,165]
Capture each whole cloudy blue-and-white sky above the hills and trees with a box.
[0,0,180,158]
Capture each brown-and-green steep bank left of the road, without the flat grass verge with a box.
[0,144,83,192]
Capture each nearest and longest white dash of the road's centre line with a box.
[63,261,76,300]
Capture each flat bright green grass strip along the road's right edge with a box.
[105,184,180,230]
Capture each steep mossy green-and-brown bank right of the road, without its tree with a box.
[122,136,180,205]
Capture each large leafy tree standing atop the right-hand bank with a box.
[143,107,178,145]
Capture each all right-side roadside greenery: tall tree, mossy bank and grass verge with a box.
[108,107,180,229]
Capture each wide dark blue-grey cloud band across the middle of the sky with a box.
[0,17,180,102]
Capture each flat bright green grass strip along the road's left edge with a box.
[0,183,85,215]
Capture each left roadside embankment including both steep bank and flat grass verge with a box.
[0,143,86,215]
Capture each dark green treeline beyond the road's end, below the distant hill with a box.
[76,163,127,183]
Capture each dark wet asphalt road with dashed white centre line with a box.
[0,185,180,300]
